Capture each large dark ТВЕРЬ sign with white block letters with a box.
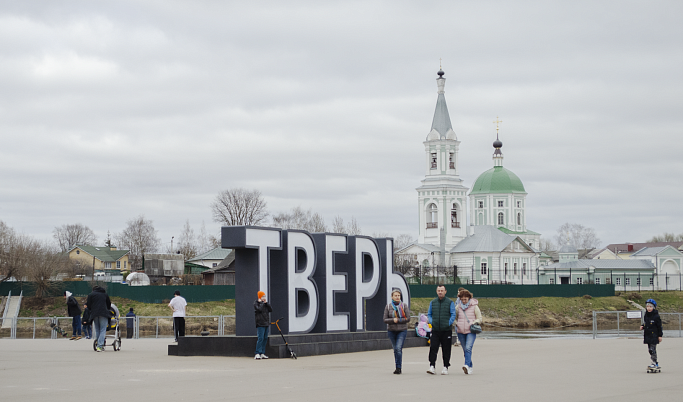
[221,226,410,336]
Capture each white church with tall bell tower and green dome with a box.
[396,70,541,284]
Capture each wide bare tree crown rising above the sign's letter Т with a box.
[211,188,268,226]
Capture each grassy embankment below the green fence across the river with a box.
[20,292,683,328]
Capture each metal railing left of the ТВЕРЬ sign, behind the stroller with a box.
[0,315,235,339]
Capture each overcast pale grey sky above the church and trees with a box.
[0,0,683,250]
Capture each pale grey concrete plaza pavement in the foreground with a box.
[0,337,683,402]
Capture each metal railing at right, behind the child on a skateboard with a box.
[593,310,683,339]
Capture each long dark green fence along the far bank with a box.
[0,282,615,303]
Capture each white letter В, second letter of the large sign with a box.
[287,232,318,332]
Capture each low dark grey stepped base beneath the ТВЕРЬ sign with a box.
[168,330,430,358]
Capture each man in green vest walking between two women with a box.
[427,285,455,375]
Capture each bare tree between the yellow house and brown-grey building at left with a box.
[114,215,161,269]
